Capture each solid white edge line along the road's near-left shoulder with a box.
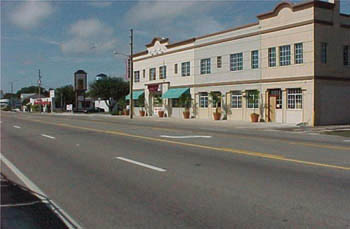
[0,153,82,229]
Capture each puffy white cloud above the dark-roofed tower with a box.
[61,18,117,55]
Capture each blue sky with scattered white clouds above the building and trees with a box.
[0,0,350,92]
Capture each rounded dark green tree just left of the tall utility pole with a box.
[88,77,129,110]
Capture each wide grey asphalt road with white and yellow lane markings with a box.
[1,113,350,229]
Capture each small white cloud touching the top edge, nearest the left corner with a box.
[10,0,54,29]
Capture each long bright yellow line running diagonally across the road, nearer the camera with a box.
[11,115,350,170]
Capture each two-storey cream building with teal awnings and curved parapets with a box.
[133,0,350,125]
